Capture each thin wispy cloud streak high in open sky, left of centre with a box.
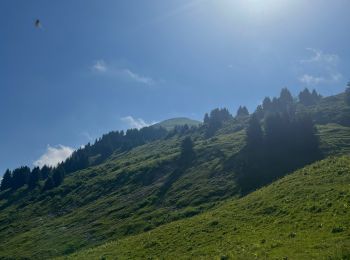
[91,59,156,86]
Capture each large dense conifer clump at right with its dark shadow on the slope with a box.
[229,88,322,193]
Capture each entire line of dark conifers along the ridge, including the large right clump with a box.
[0,84,350,194]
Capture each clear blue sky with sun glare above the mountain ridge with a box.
[0,0,350,175]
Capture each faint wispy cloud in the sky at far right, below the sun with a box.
[299,48,343,86]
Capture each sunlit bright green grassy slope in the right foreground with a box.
[66,156,350,259]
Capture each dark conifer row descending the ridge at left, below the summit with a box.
[0,126,168,191]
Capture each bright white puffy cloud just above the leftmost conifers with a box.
[33,144,74,167]
